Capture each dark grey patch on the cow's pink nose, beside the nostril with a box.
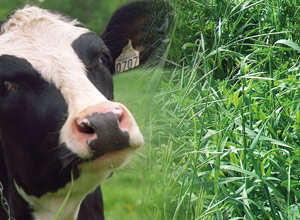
[86,112,129,158]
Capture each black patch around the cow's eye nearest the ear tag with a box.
[72,32,113,100]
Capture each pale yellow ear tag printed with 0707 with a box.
[115,40,140,73]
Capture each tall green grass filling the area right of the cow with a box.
[104,0,300,220]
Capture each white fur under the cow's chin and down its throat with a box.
[15,149,132,220]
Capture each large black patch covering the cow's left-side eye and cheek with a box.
[0,55,79,198]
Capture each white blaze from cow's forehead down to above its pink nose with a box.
[0,7,104,111]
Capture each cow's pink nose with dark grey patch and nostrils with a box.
[73,102,139,158]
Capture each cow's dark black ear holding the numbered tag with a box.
[101,0,171,73]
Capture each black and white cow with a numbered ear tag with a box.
[0,2,169,220]
